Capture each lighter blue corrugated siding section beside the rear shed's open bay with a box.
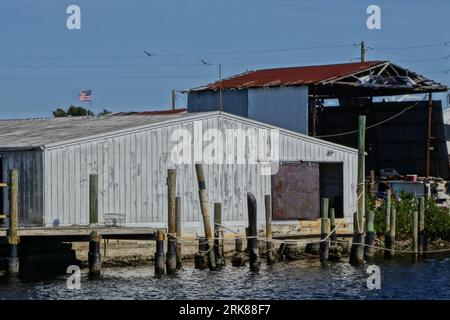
[248,86,308,134]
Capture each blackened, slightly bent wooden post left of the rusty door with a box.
[247,192,261,272]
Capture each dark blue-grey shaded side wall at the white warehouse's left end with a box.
[0,150,44,226]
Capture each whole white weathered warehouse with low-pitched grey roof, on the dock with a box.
[0,111,357,230]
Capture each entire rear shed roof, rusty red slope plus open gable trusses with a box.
[191,61,447,98]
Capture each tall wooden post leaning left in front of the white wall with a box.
[195,163,216,270]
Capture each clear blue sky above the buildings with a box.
[0,0,450,118]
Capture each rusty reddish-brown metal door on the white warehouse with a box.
[272,162,320,220]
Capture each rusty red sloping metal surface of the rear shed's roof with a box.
[193,61,386,91]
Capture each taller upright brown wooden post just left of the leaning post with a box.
[166,169,177,274]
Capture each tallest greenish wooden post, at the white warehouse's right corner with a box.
[350,116,366,265]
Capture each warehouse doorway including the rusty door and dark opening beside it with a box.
[272,161,343,220]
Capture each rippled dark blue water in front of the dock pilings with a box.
[0,257,450,300]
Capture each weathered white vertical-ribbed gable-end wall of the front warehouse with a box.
[44,114,357,229]
